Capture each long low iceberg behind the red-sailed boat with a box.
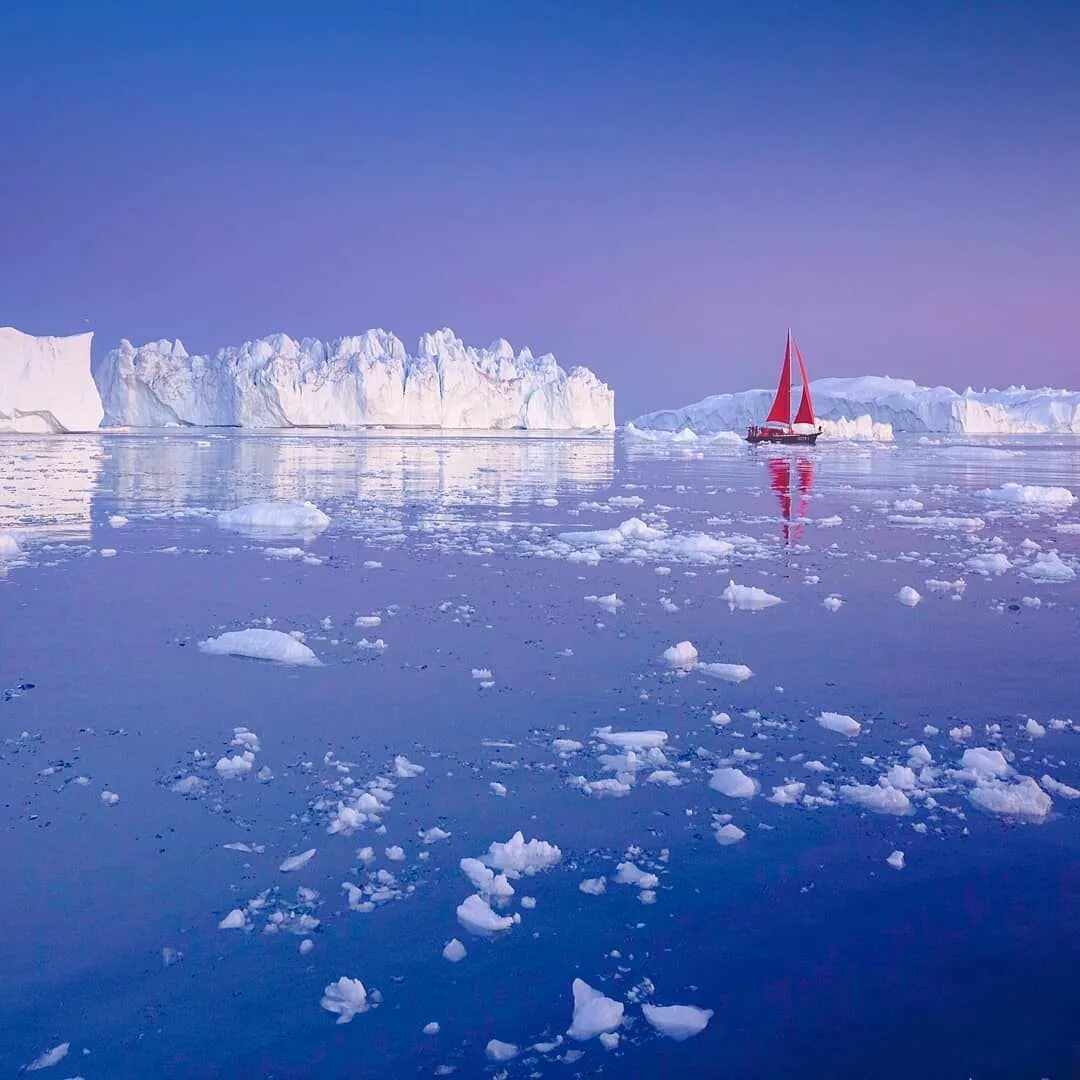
[633,375,1080,438]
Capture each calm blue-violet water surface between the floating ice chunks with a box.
[0,432,1080,1080]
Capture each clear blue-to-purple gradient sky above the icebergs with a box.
[0,0,1080,419]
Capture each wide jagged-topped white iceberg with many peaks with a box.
[94,329,615,431]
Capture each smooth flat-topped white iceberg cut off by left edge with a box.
[0,326,102,432]
